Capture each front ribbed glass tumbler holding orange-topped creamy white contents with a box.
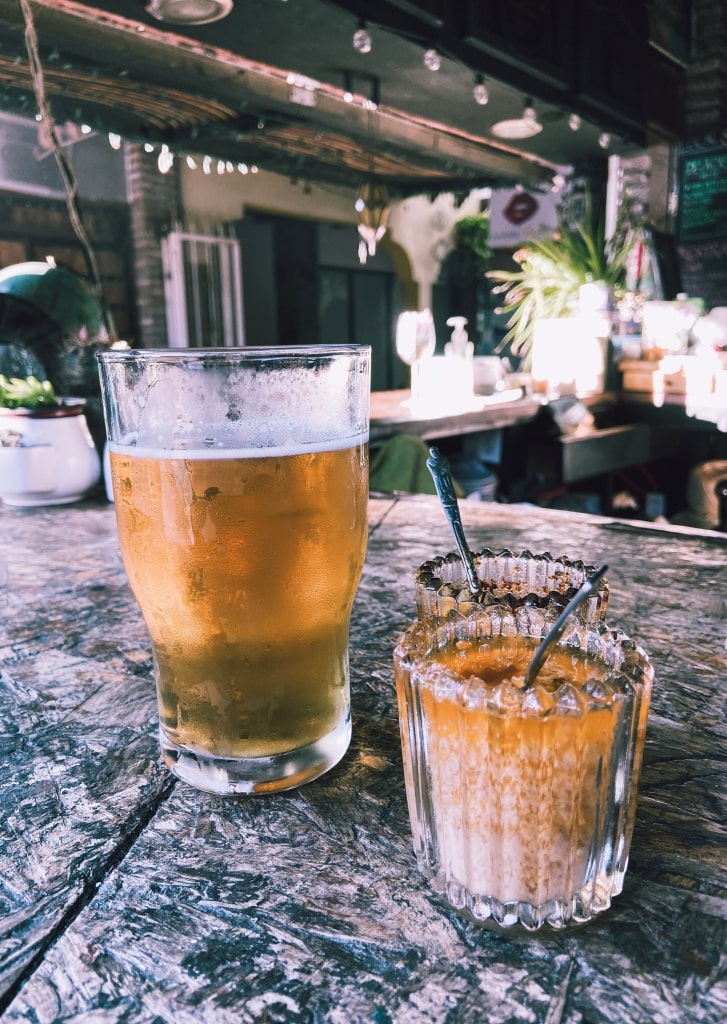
[394,604,653,932]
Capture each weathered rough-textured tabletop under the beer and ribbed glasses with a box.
[0,496,727,1024]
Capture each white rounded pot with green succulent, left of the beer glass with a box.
[0,374,100,507]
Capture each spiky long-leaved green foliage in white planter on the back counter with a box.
[487,193,638,358]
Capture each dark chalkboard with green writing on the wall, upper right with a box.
[677,144,727,242]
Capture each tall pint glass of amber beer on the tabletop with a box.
[98,345,371,795]
